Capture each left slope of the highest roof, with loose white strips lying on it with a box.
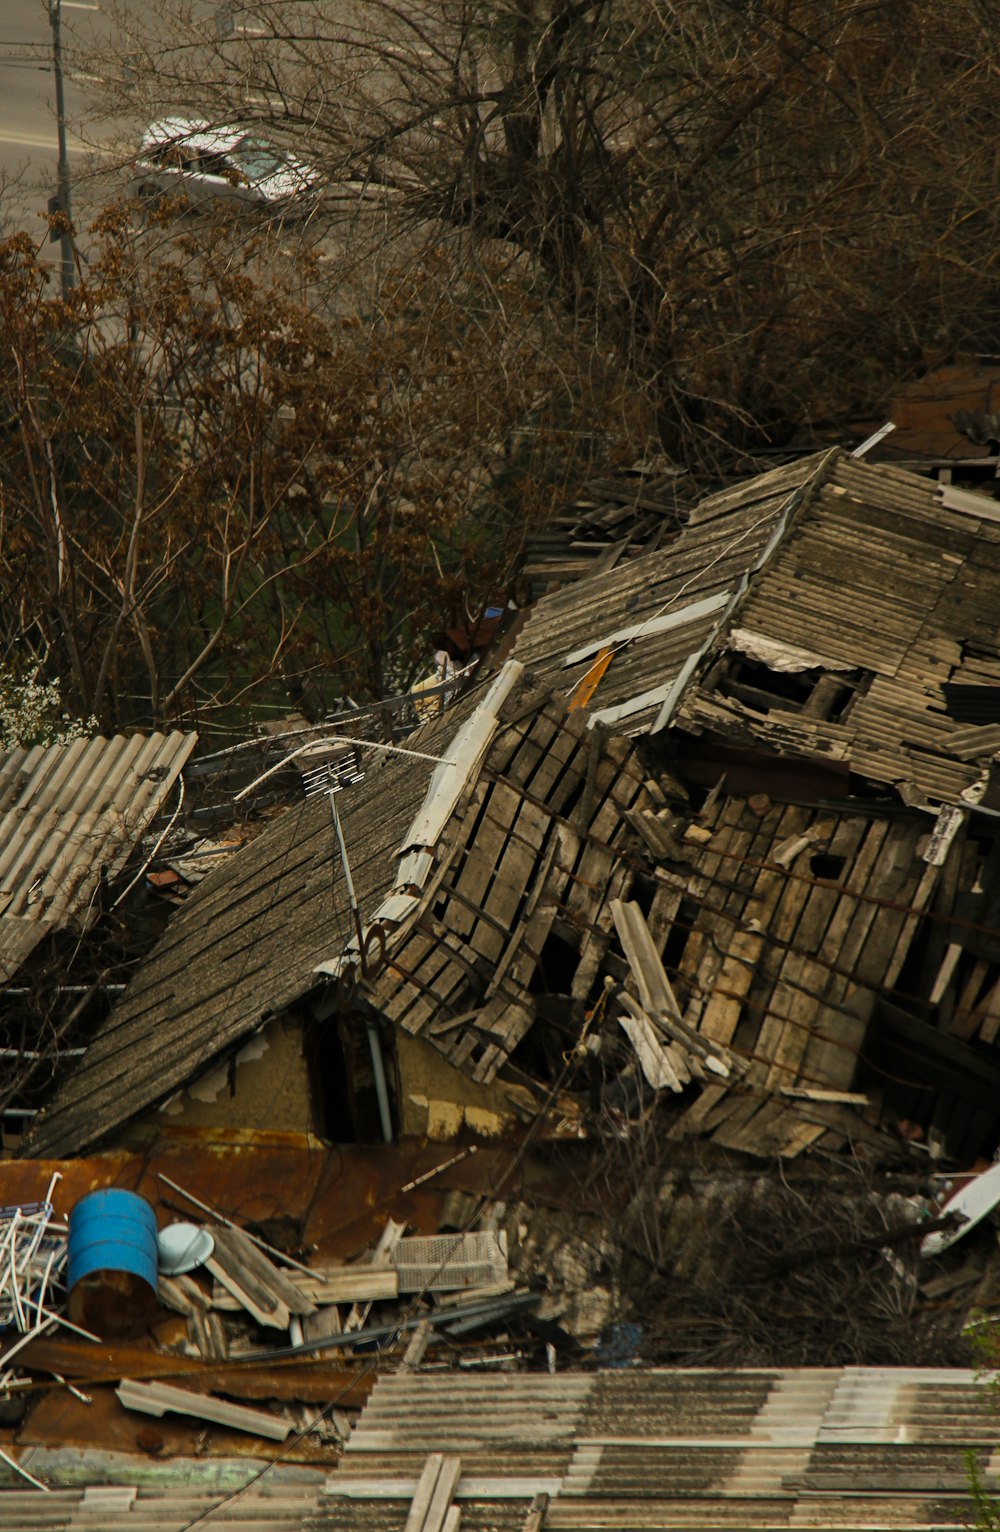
[515,453,830,734]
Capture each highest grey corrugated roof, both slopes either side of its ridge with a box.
[515,452,1000,806]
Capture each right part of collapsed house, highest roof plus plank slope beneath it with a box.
[516,452,1000,1155]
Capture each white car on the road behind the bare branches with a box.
[129,116,320,218]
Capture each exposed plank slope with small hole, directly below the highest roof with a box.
[640,794,943,1157]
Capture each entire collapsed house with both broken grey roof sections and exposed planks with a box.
[29,452,1000,1157]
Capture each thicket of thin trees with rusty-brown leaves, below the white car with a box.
[0,208,600,726]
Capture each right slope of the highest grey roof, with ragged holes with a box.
[677,455,1000,804]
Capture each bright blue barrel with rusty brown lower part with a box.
[66,1187,156,1336]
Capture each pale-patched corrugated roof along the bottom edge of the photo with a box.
[315,1368,997,1532]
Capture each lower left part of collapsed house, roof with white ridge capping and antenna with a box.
[21,663,661,1155]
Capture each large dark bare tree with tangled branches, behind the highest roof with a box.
[80,0,1000,464]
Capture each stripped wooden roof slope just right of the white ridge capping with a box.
[362,691,651,1090]
